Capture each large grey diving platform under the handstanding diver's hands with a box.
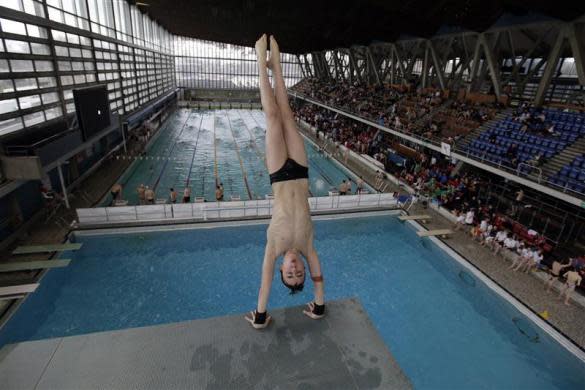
[0,299,412,390]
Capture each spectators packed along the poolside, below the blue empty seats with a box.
[392,152,585,304]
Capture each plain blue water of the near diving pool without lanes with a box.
[0,216,585,389]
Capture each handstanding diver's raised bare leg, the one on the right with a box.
[268,36,308,167]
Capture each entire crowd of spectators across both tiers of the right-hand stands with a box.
[294,80,585,303]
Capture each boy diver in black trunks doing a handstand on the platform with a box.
[246,34,325,329]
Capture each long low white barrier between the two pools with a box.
[77,193,399,226]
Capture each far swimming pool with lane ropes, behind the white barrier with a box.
[110,109,364,205]
